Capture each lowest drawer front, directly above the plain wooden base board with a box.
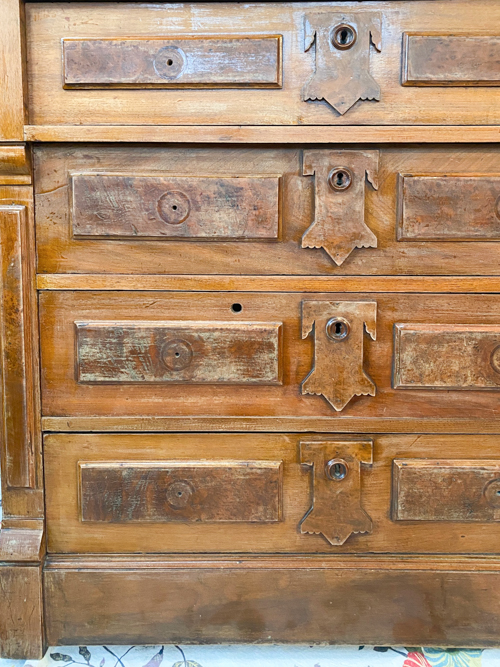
[44,433,500,554]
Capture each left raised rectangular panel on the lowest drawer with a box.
[78,461,282,523]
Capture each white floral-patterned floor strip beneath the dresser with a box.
[0,638,500,667]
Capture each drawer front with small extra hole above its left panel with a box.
[40,291,500,420]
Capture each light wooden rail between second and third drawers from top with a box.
[36,273,500,294]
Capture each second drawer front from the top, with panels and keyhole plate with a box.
[35,145,500,275]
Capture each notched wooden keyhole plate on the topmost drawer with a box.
[302,12,382,116]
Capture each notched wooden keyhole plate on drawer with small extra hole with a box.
[302,301,377,411]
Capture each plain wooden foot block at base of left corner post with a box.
[0,563,45,660]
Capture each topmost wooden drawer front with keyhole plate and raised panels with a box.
[27,0,500,125]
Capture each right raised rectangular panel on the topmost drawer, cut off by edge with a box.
[402,33,500,86]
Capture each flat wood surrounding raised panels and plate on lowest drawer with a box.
[45,430,500,559]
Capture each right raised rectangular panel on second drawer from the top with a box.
[398,174,500,241]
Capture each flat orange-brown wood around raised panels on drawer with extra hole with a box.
[40,291,500,422]
